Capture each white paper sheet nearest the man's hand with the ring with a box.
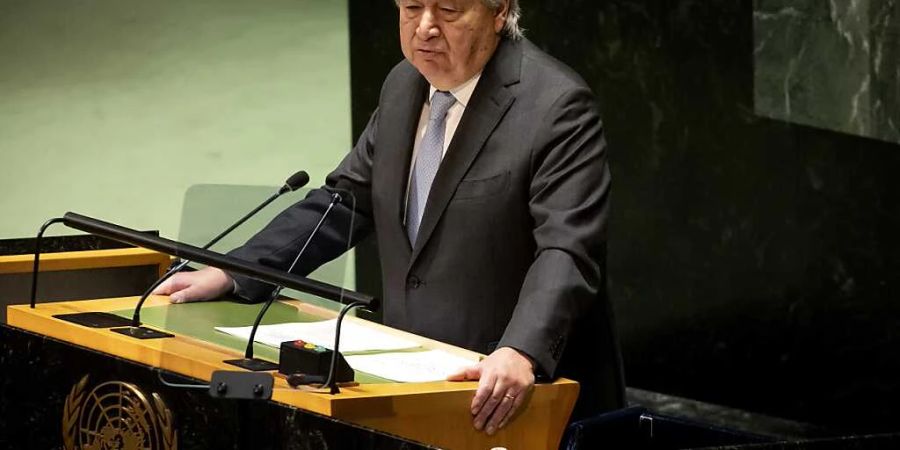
[345,350,478,383]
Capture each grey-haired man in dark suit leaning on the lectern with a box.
[157,0,623,434]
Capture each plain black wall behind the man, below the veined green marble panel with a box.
[349,0,900,432]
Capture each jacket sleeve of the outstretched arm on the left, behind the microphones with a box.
[229,111,378,301]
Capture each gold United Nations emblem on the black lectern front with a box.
[62,375,178,450]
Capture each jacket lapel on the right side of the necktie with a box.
[407,39,522,267]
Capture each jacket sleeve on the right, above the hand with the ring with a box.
[499,83,610,376]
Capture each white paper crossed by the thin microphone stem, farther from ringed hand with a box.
[216,319,419,353]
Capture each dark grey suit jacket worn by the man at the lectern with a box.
[233,39,623,417]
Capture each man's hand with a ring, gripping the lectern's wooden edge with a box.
[447,347,534,435]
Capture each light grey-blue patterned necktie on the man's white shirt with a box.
[406,91,456,245]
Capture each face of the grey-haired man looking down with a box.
[398,0,508,90]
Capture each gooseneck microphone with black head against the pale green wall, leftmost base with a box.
[112,170,309,339]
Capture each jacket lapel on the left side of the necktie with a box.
[376,69,428,256]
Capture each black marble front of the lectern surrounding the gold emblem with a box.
[0,325,428,449]
